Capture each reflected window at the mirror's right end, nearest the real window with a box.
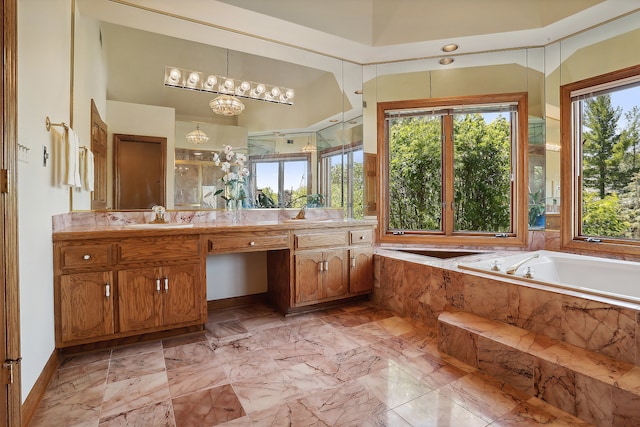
[320,142,364,219]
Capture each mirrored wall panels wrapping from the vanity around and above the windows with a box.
[72,0,640,228]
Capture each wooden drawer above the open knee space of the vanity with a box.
[207,233,289,253]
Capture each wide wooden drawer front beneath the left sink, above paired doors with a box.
[119,236,200,263]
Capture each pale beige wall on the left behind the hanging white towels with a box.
[17,0,71,400]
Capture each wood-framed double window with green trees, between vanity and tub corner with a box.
[378,94,527,245]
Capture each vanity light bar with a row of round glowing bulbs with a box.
[164,66,295,105]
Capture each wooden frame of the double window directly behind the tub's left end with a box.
[377,92,528,247]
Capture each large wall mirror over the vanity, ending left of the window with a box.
[71,0,363,217]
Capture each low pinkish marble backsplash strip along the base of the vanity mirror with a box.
[52,208,344,232]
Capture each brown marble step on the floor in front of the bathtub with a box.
[438,311,640,427]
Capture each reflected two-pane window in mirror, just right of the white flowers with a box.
[249,154,311,208]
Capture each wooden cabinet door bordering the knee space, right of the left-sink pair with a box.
[162,264,201,325]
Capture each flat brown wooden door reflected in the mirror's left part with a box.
[113,134,167,210]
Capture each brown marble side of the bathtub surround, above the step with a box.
[373,248,640,366]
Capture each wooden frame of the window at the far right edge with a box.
[560,65,640,257]
